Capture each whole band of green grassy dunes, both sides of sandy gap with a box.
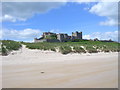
[0,40,120,55]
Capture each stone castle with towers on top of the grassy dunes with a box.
[34,31,82,42]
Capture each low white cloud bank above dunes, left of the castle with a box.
[1,28,41,41]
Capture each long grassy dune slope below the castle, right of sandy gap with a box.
[24,41,120,54]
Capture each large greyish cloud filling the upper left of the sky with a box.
[2,2,65,22]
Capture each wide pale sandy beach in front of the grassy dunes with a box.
[0,46,118,88]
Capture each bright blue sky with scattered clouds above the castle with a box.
[0,2,118,42]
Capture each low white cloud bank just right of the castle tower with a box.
[83,31,118,41]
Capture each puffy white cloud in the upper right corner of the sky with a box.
[89,2,118,26]
